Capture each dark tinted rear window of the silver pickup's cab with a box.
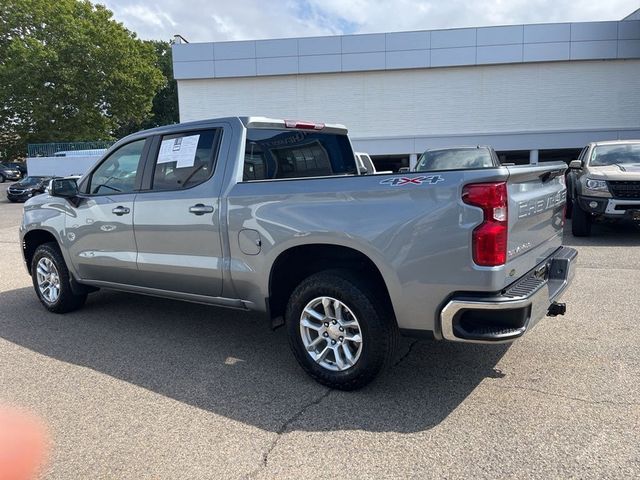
[243,128,357,182]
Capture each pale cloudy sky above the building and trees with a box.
[100,0,640,42]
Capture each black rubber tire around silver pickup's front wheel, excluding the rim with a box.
[31,242,87,313]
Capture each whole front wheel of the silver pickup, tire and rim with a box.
[31,243,87,313]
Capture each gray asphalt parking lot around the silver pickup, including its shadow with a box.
[0,183,640,479]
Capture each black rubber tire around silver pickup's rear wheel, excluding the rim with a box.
[285,270,399,390]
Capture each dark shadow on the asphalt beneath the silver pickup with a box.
[0,288,508,433]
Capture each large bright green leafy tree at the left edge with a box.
[0,0,167,158]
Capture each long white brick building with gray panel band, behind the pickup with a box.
[173,10,640,168]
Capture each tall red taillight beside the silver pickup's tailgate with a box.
[462,182,509,267]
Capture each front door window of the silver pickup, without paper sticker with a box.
[87,139,146,195]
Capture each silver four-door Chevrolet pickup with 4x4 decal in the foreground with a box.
[20,117,576,389]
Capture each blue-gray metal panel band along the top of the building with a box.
[173,20,640,80]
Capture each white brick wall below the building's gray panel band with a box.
[178,60,640,153]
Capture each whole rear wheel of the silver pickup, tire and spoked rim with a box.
[285,270,398,390]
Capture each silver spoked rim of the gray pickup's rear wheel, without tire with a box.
[300,297,362,372]
